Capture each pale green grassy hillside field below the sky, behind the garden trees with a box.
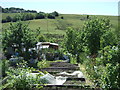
[2,13,118,34]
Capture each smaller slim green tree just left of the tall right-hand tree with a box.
[65,28,84,62]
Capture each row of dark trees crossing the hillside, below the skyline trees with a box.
[2,11,59,23]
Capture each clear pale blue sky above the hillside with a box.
[0,0,120,15]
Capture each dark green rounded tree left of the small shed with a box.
[2,22,36,59]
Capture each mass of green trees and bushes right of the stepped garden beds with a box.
[65,18,120,90]
